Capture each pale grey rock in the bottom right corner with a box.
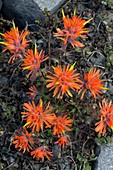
[94,139,113,170]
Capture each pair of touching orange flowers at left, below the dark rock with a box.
[0,22,48,79]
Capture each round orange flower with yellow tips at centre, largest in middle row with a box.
[46,64,81,98]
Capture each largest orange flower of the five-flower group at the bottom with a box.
[21,99,55,132]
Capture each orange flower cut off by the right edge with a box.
[95,100,113,136]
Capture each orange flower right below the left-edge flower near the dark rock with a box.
[22,44,48,77]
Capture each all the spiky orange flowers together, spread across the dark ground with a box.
[0,11,113,162]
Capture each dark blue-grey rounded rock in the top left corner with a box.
[3,0,44,30]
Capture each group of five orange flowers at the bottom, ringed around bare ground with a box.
[13,99,73,162]
